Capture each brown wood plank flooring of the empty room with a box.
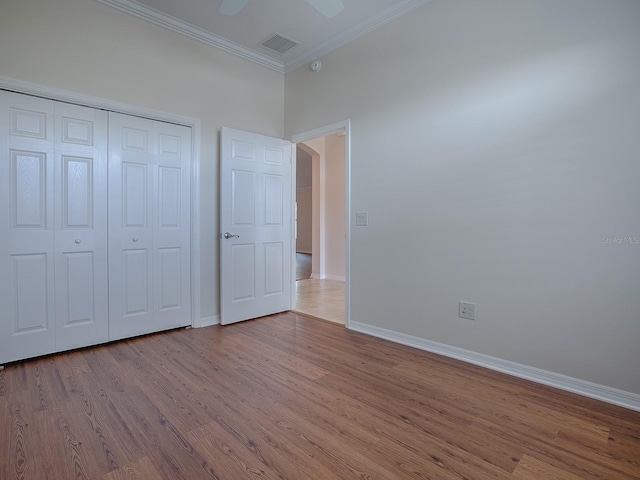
[0,313,640,480]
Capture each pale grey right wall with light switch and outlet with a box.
[285,0,640,394]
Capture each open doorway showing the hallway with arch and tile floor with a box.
[291,122,349,326]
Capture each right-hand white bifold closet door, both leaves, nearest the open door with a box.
[109,113,191,340]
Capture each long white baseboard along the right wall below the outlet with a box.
[348,320,640,412]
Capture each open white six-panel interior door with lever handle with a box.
[220,128,292,325]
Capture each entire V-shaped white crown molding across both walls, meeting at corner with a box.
[95,0,431,74]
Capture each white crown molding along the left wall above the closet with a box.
[95,0,284,73]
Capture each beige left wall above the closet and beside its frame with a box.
[0,0,284,326]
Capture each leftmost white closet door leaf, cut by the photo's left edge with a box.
[0,91,55,363]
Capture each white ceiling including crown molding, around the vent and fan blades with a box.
[97,0,430,73]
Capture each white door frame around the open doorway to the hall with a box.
[285,120,351,328]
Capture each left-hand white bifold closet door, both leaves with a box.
[0,91,108,363]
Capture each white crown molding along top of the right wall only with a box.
[284,0,432,73]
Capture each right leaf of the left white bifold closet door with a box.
[54,103,109,351]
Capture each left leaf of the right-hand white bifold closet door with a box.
[108,113,157,340]
